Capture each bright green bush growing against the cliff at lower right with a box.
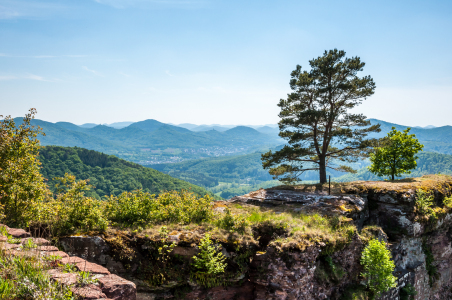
[361,239,397,297]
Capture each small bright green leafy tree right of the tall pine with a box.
[369,127,424,180]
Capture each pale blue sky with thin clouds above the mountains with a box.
[0,0,452,126]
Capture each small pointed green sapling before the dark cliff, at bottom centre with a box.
[192,234,227,288]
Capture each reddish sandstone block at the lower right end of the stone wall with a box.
[99,274,137,300]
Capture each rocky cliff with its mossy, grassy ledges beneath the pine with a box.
[28,176,452,300]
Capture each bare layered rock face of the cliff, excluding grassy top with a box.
[37,177,452,300]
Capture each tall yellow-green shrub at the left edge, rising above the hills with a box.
[0,109,47,226]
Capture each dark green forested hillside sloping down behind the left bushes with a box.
[39,146,209,198]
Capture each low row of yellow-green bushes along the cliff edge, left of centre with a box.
[105,191,213,226]
